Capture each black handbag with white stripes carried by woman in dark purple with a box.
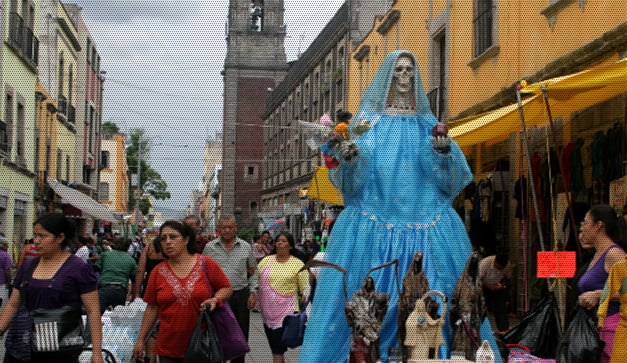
[32,306,87,352]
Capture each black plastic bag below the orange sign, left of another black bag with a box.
[503,292,562,359]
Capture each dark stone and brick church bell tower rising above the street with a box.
[220,0,288,227]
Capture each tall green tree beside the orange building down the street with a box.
[126,129,170,215]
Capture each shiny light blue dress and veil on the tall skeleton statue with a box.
[299,51,506,363]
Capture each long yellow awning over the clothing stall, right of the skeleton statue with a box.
[449,58,627,147]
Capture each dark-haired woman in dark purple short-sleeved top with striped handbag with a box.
[0,213,102,363]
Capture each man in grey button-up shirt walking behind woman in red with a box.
[203,216,259,363]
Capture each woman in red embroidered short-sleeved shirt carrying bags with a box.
[133,221,232,363]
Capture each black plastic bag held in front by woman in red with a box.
[183,310,224,363]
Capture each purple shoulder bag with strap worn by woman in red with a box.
[200,257,250,360]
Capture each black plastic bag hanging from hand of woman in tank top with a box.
[557,307,605,363]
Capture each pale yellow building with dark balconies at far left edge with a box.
[0,0,39,252]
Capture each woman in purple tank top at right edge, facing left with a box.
[577,205,627,362]
